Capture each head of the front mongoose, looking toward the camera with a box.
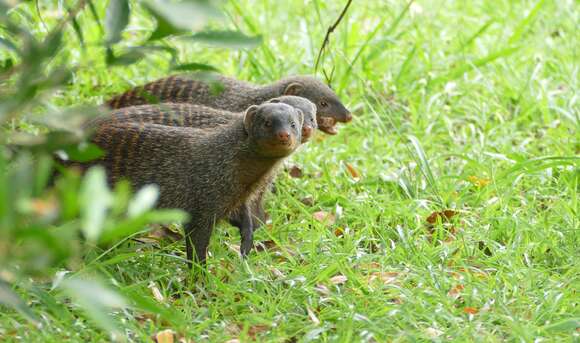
[244,103,304,158]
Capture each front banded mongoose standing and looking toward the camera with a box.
[91,103,304,267]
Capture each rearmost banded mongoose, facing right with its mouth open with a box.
[107,75,352,135]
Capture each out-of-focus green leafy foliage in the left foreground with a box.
[0,0,261,337]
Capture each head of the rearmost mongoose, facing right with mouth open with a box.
[283,76,352,135]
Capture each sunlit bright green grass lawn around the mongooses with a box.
[0,0,580,342]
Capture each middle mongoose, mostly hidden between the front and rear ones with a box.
[106,95,316,256]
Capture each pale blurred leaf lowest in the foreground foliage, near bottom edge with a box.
[60,278,127,333]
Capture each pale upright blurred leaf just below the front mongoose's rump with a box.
[80,166,113,242]
